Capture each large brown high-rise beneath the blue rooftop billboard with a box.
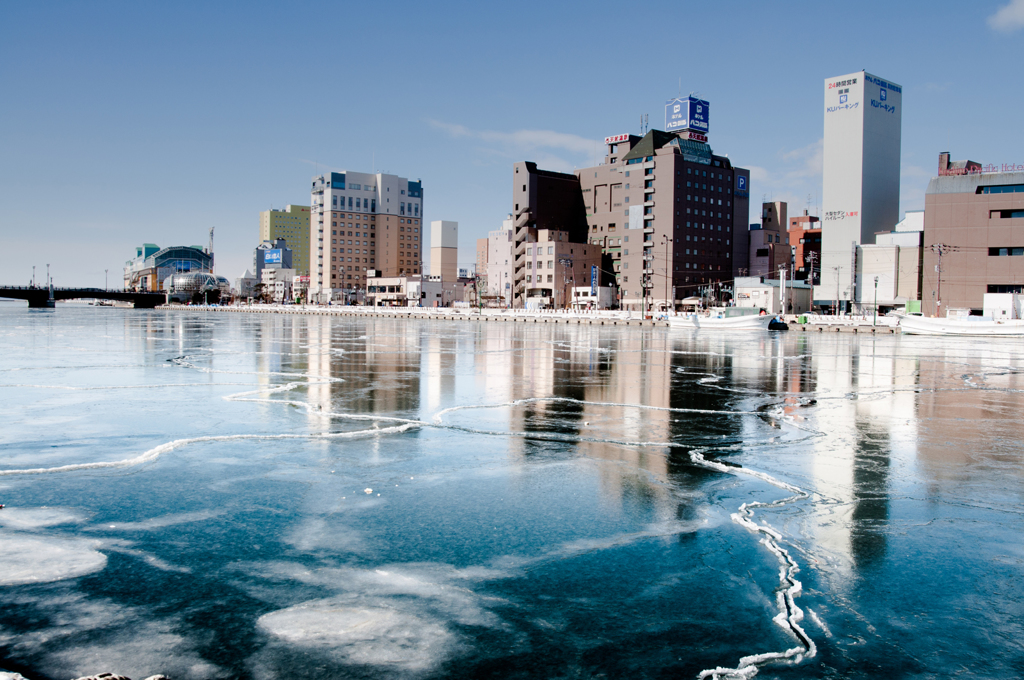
[577,130,750,309]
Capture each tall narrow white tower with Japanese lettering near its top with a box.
[814,71,903,304]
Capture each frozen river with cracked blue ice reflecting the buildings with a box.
[0,303,1024,680]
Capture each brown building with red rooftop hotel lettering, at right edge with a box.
[922,153,1024,316]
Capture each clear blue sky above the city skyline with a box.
[0,0,1024,285]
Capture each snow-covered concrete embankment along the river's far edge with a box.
[162,304,897,335]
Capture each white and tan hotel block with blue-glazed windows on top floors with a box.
[309,172,425,302]
